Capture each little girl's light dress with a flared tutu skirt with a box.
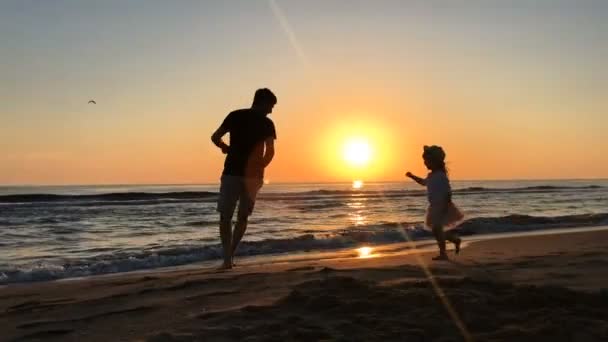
[424,171,464,230]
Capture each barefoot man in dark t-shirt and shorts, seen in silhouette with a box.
[211,88,277,269]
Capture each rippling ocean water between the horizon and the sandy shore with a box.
[0,180,608,284]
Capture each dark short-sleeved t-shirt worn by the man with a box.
[220,108,277,178]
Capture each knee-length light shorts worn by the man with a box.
[217,175,264,218]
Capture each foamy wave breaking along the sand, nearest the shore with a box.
[0,213,608,284]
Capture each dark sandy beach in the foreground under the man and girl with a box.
[0,230,608,341]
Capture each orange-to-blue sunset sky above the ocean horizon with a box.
[0,0,608,185]
